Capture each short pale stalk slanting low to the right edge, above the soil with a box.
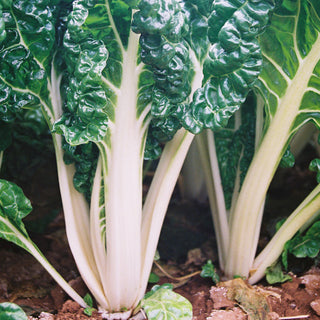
[249,184,320,284]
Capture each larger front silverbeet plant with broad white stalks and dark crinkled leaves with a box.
[0,0,273,319]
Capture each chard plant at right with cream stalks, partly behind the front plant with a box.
[192,0,320,283]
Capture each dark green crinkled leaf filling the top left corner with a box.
[0,0,65,121]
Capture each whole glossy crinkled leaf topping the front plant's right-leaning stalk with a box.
[133,0,273,141]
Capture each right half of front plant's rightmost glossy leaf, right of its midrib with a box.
[183,0,273,133]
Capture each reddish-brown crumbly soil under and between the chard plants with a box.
[0,146,320,320]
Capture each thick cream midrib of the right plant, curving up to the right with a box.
[226,38,320,276]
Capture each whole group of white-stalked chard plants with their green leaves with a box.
[0,0,320,320]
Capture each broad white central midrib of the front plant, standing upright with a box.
[102,32,144,311]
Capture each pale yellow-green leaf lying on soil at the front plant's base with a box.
[141,286,192,320]
